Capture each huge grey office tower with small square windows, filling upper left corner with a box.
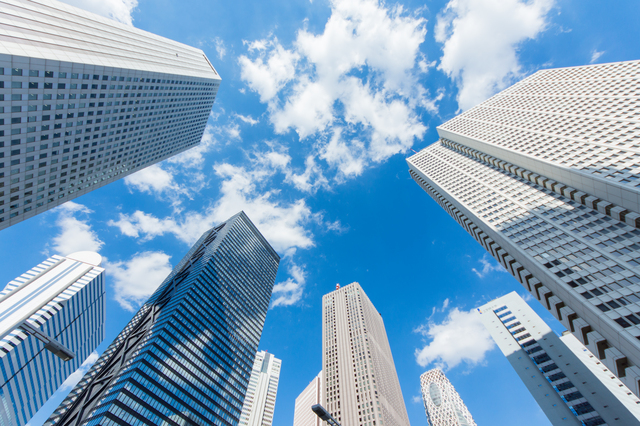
[0,0,220,229]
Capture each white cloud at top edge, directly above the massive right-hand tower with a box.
[435,0,554,110]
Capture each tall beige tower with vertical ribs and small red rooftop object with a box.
[322,283,409,426]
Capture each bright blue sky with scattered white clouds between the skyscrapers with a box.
[0,0,640,426]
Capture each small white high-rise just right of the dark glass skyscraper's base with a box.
[239,351,282,426]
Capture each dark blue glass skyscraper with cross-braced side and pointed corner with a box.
[47,212,280,425]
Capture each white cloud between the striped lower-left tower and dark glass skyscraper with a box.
[105,251,172,312]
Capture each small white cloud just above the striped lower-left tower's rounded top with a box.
[51,201,104,256]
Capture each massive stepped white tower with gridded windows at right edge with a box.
[407,61,640,395]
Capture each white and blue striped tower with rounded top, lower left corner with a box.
[0,252,104,426]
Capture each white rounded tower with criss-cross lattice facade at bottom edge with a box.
[420,368,476,426]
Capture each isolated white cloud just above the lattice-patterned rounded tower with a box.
[414,308,495,370]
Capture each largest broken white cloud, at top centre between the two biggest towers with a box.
[239,0,432,186]
